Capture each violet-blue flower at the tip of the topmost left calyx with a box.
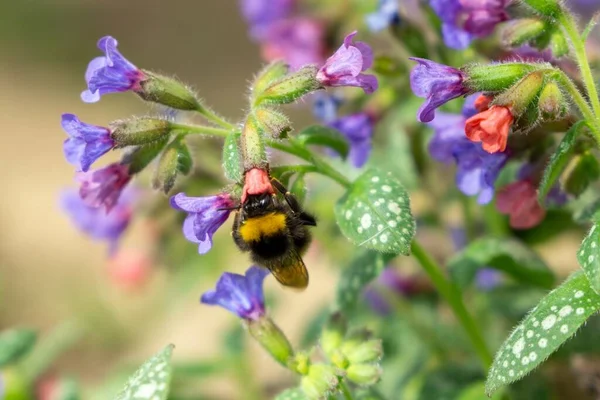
[81,36,146,103]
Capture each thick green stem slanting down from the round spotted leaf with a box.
[411,240,492,369]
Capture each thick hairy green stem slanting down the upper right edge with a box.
[558,10,600,125]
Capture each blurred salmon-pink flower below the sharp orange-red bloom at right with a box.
[496,179,546,229]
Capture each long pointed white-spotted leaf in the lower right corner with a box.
[486,272,600,395]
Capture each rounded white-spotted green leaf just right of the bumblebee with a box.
[335,169,415,255]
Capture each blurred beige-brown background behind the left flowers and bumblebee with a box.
[0,0,334,398]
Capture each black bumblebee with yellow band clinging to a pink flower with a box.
[232,179,317,289]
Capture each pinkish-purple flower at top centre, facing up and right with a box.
[317,31,378,93]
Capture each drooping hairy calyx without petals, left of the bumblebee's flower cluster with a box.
[152,138,192,194]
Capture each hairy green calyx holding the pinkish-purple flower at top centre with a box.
[254,65,321,107]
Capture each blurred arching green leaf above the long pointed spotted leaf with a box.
[448,237,554,289]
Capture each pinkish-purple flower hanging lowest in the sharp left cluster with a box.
[77,163,131,212]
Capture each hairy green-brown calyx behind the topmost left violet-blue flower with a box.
[136,70,202,111]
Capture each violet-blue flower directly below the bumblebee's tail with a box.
[200,266,269,321]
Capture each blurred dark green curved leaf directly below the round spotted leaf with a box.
[337,251,393,312]
